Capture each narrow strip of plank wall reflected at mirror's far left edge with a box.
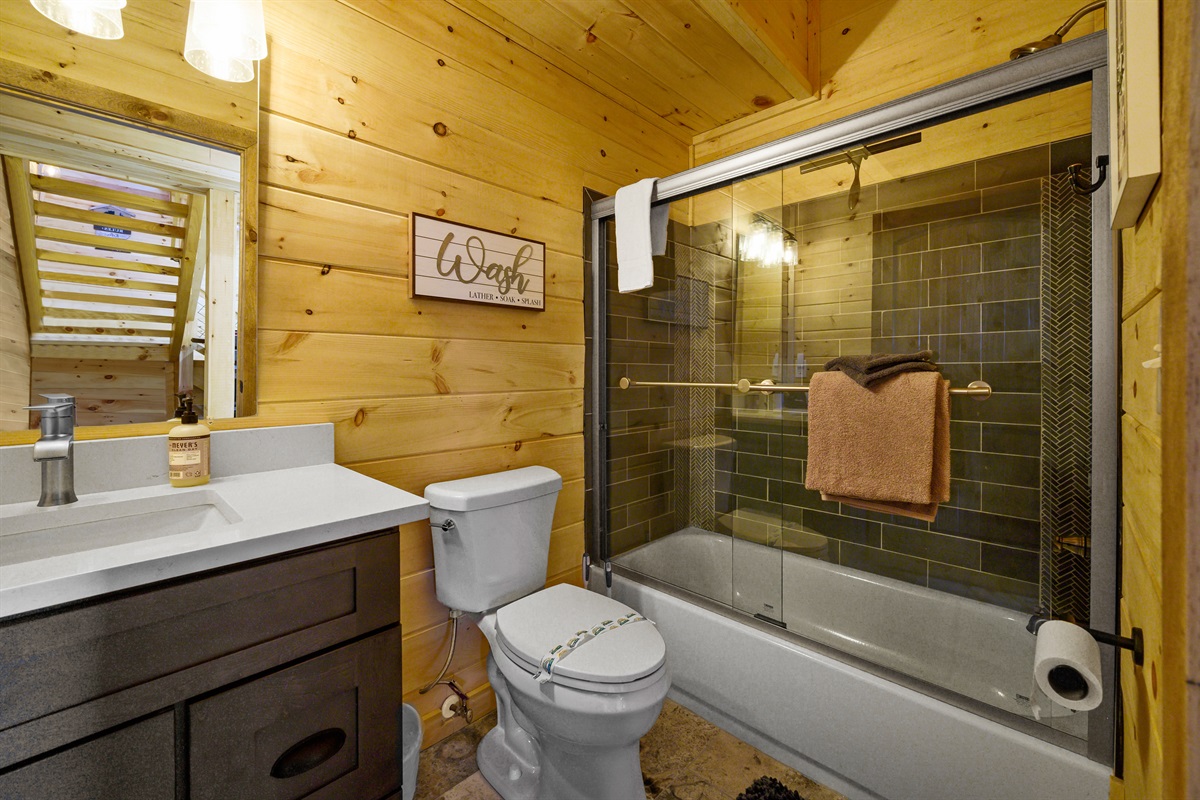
[0,165,29,431]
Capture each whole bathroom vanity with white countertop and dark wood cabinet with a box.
[0,426,427,800]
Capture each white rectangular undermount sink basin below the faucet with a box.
[0,489,241,567]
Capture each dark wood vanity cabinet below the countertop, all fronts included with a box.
[0,529,401,800]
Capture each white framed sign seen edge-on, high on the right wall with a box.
[1106,0,1163,230]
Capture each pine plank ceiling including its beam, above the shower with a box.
[451,0,817,142]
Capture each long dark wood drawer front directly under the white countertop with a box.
[0,530,400,765]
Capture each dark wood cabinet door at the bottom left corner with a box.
[0,711,175,800]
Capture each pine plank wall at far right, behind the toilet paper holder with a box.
[1114,2,1200,799]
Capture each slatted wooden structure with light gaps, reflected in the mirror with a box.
[4,156,205,361]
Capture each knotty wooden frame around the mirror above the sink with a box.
[0,59,258,446]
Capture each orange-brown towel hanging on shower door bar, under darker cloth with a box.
[804,372,950,518]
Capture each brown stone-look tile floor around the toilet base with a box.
[415,700,845,800]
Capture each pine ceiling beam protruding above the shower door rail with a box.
[696,0,818,100]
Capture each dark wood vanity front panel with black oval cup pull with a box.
[190,628,400,800]
